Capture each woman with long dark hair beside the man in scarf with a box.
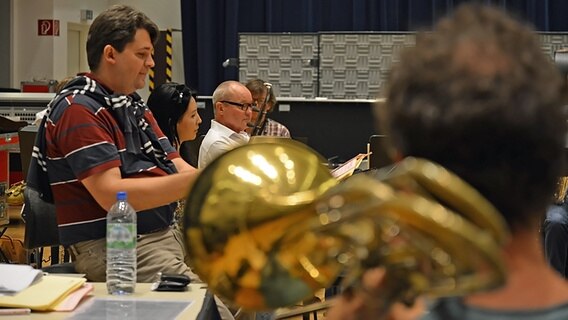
[147,82,201,166]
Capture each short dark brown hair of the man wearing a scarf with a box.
[87,5,159,71]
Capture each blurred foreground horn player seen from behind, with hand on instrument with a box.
[326,4,568,320]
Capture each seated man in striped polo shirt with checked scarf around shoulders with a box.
[28,5,233,319]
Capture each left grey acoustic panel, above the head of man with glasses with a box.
[239,33,319,98]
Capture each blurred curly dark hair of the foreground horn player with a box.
[386,5,566,231]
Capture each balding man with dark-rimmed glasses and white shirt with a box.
[198,81,254,168]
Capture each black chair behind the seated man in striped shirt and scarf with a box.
[18,126,75,273]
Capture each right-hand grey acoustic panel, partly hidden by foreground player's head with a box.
[319,32,415,99]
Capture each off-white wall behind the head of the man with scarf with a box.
[11,0,183,98]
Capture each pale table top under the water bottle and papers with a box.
[9,282,206,320]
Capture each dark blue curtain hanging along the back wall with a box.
[181,0,568,95]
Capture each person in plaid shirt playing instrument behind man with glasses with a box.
[245,79,290,138]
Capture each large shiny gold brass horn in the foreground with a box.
[184,137,508,310]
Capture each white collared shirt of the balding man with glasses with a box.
[197,120,250,168]
